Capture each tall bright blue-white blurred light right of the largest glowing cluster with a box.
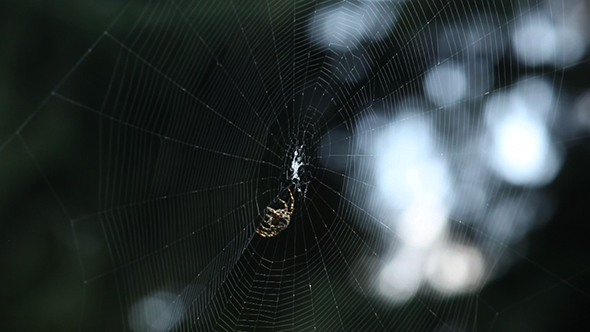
[485,80,562,186]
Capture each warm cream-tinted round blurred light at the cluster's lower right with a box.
[425,243,485,295]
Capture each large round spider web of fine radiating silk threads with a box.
[0,0,588,331]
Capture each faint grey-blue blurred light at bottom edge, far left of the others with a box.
[128,291,184,331]
